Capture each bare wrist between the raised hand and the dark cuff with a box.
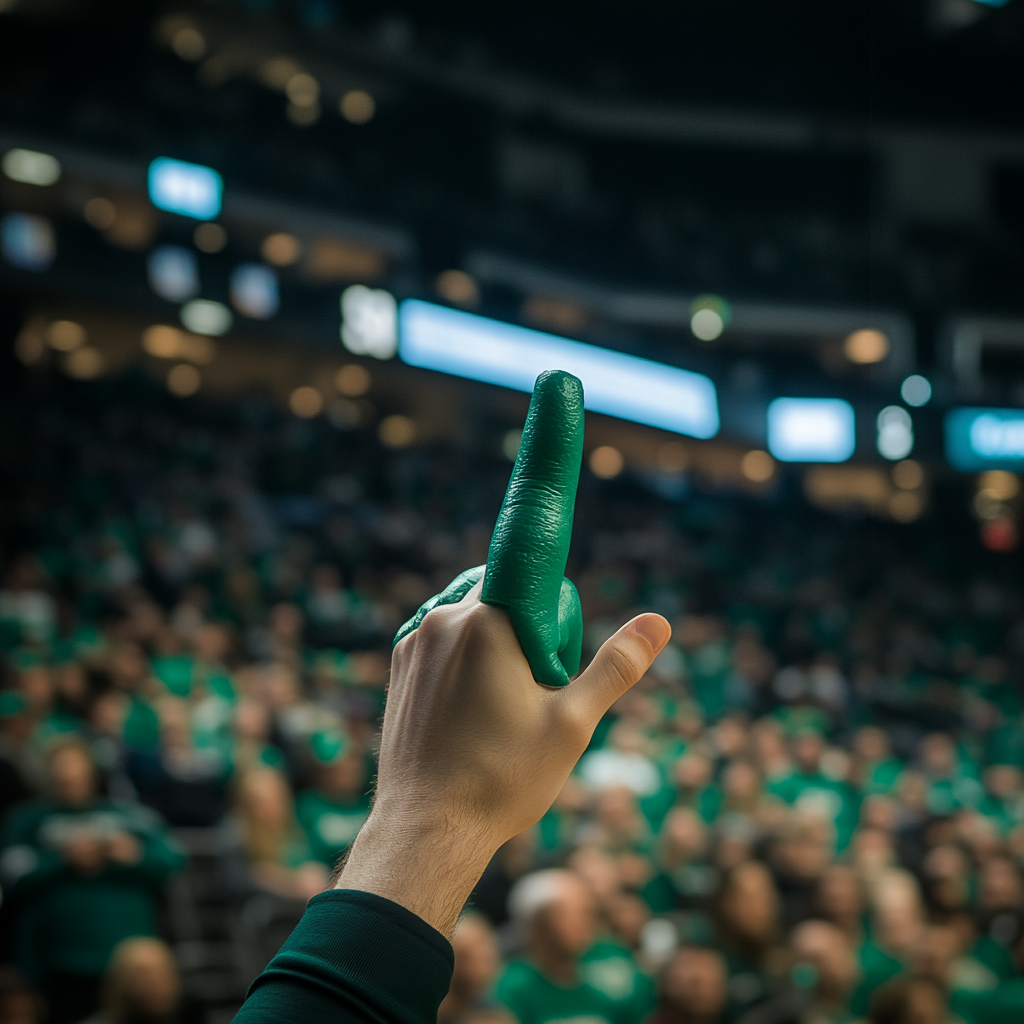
[335,804,501,937]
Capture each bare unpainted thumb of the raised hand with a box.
[563,612,672,726]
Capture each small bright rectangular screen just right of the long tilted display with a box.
[768,398,857,462]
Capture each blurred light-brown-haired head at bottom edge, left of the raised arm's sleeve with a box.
[103,937,181,1024]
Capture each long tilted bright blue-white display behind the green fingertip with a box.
[398,299,719,437]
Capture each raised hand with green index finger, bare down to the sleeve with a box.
[338,374,671,934]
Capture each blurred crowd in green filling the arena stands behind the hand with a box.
[0,379,1024,1024]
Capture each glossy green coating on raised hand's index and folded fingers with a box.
[395,370,583,686]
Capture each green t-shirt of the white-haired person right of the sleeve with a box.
[496,959,636,1024]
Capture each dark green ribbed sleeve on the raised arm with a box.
[234,889,455,1024]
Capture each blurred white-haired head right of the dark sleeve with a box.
[509,868,597,958]
